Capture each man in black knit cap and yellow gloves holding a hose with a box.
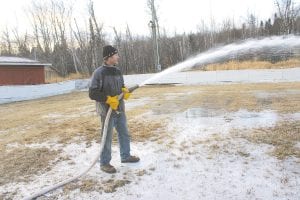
[89,45,140,173]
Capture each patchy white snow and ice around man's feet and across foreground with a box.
[0,94,300,200]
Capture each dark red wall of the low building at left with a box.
[0,66,45,85]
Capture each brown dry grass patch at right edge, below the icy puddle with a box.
[192,120,300,160]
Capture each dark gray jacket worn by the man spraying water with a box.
[89,65,125,116]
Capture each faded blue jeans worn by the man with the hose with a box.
[100,111,130,165]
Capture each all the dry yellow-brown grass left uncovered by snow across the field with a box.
[0,82,300,198]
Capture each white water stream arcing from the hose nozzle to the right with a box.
[140,35,300,86]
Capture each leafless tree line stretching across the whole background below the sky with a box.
[0,0,300,76]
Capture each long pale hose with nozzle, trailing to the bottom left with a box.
[23,85,139,200]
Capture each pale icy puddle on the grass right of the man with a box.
[171,108,284,137]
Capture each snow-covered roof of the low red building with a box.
[0,56,51,67]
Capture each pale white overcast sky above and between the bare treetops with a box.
[0,0,300,35]
